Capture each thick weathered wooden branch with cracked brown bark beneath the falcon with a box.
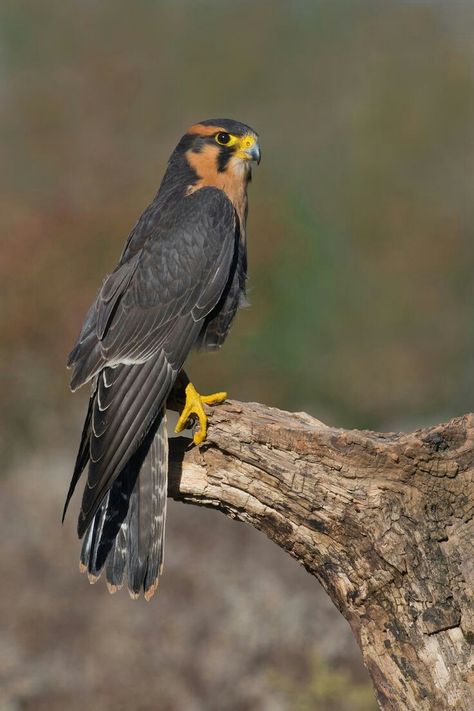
[170,401,474,711]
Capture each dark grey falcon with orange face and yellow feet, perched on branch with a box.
[63,119,260,600]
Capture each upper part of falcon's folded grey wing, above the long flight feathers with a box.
[69,188,237,388]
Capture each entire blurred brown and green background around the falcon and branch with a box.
[0,0,474,711]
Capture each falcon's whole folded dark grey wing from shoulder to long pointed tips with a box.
[66,188,237,536]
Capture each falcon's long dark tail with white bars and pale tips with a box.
[81,410,168,600]
